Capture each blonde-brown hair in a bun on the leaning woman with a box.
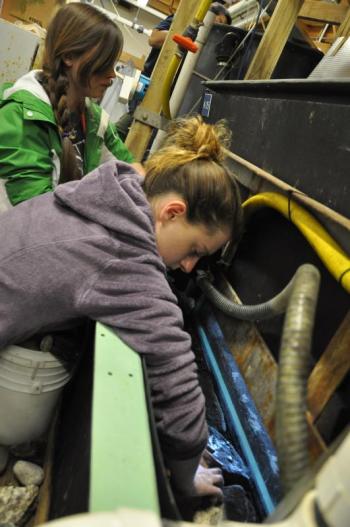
[144,116,242,242]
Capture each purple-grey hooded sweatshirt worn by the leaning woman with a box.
[0,161,207,459]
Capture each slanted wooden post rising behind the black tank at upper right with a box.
[245,0,303,80]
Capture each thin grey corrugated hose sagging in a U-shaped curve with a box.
[197,270,294,321]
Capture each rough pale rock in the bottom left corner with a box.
[0,485,39,525]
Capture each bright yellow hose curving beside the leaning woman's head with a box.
[243,192,350,293]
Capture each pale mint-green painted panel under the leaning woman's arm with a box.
[89,323,159,513]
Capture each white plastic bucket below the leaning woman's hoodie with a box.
[0,346,73,446]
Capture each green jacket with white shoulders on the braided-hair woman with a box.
[0,71,133,212]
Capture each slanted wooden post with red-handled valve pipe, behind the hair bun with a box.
[125,0,198,161]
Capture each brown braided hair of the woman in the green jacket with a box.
[43,3,123,183]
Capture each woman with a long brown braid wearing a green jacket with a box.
[0,3,137,212]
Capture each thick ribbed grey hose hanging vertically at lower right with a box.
[276,264,320,492]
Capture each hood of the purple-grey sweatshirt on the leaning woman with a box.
[54,160,158,254]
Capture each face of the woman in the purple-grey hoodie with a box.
[156,197,230,273]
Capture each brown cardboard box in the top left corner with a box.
[1,0,65,28]
